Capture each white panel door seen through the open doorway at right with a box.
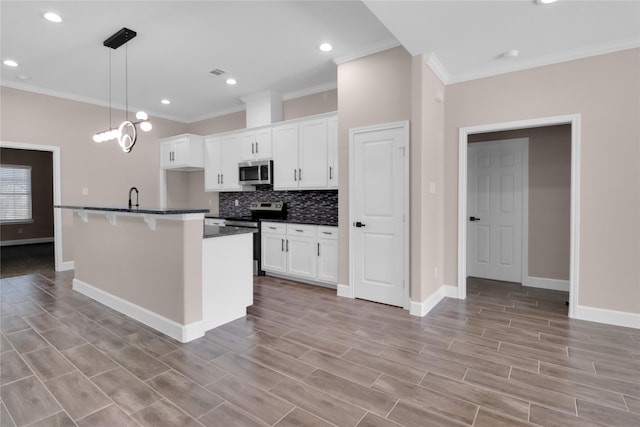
[467,138,528,283]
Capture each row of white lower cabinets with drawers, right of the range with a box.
[262,222,338,285]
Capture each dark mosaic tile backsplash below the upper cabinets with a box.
[219,185,338,224]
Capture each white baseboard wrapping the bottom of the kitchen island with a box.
[73,279,204,343]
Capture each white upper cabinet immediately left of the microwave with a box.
[204,134,242,191]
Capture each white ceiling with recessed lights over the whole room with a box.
[0,0,640,122]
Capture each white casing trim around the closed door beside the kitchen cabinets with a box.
[348,120,411,310]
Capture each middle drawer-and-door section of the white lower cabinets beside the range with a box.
[287,224,317,279]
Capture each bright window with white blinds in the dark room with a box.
[0,165,32,224]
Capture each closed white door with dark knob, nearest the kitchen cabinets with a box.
[349,123,409,307]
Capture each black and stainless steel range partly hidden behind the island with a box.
[211,202,287,276]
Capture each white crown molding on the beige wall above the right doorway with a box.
[444,38,640,84]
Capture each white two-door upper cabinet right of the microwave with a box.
[273,116,337,190]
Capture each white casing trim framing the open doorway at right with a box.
[458,113,581,318]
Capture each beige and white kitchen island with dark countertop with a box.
[55,205,253,342]
